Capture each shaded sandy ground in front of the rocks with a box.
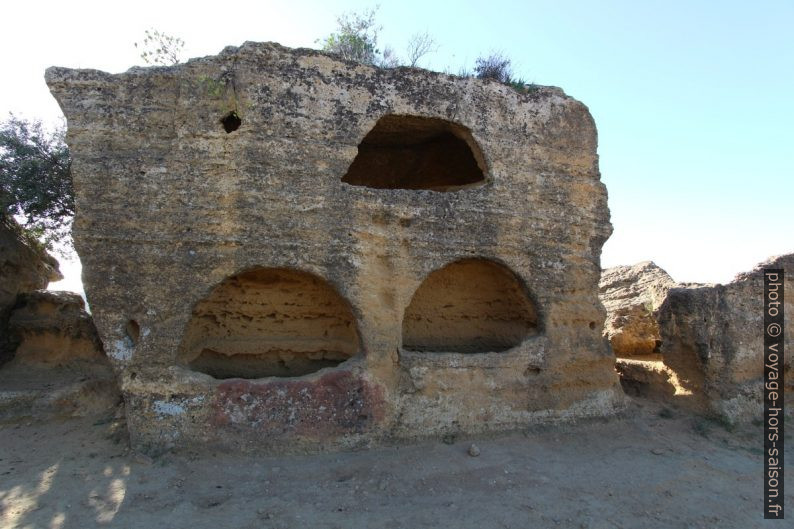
[0,400,794,529]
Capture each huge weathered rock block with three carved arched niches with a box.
[46,43,623,450]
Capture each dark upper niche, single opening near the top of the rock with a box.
[342,114,485,191]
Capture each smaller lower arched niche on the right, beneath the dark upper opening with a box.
[403,259,538,353]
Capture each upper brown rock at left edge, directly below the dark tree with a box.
[0,214,63,365]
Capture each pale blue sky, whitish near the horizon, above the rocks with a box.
[0,0,794,282]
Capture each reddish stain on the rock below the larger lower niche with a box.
[213,371,383,437]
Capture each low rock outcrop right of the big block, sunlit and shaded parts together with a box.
[600,254,794,422]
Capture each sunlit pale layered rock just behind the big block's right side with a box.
[598,261,675,357]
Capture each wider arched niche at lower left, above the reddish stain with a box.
[179,268,359,379]
